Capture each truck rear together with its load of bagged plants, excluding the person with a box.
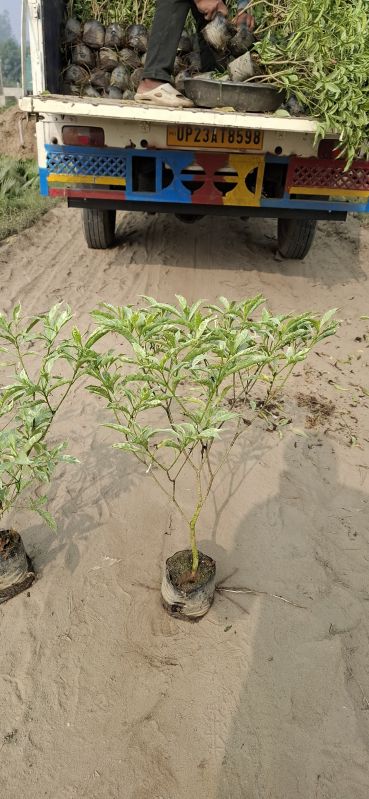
[21,0,369,258]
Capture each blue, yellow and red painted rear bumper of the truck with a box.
[40,145,369,214]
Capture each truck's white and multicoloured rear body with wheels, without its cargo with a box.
[20,0,369,259]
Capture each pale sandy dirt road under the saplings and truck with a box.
[0,208,369,799]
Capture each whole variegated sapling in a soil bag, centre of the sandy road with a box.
[84,296,336,618]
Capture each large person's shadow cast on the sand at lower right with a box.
[204,438,369,799]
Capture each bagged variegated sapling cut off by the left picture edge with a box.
[0,305,88,604]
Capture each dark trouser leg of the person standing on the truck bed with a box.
[139,0,191,84]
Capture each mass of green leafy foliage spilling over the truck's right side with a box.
[254,0,369,163]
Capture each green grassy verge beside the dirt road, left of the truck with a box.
[0,155,54,241]
